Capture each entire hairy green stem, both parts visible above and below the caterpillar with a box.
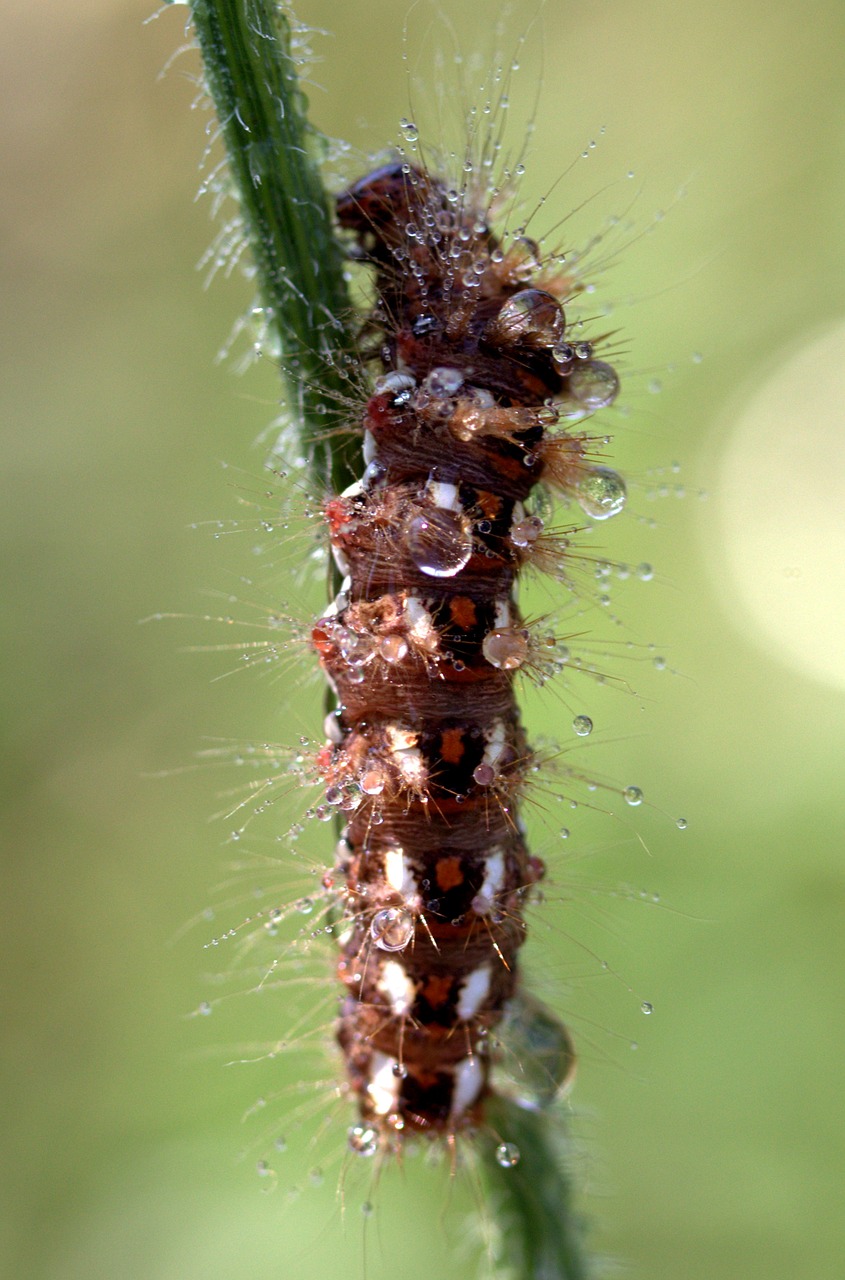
[181,0,586,1280]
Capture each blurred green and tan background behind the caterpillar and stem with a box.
[0,0,845,1280]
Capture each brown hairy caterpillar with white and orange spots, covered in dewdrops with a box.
[312,161,625,1153]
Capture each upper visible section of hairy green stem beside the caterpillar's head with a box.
[189,0,358,493]
